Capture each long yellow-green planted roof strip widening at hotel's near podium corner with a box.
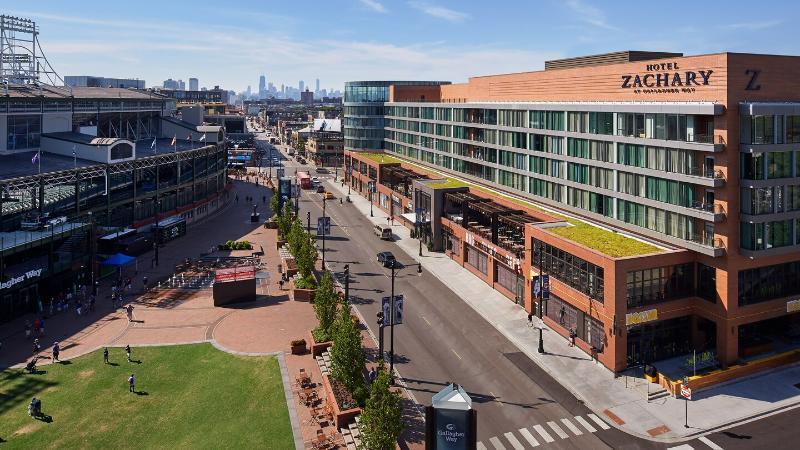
[394,161,663,258]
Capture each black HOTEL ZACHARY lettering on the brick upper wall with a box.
[621,62,714,94]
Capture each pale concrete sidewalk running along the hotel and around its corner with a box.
[329,177,800,442]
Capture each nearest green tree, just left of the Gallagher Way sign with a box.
[361,361,405,450]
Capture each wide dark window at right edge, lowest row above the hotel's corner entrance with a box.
[738,261,800,306]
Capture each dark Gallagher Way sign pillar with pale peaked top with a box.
[425,384,478,450]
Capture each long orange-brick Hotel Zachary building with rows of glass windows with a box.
[344,51,800,387]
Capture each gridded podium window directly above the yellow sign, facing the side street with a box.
[626,263,694,308]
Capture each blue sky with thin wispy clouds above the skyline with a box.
[7,0,800,91]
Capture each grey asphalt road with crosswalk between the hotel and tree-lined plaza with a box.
[260,138,666,449]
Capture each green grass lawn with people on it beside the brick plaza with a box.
[0,344,294,449]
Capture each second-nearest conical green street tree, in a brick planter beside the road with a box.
[330,301,367,400]
